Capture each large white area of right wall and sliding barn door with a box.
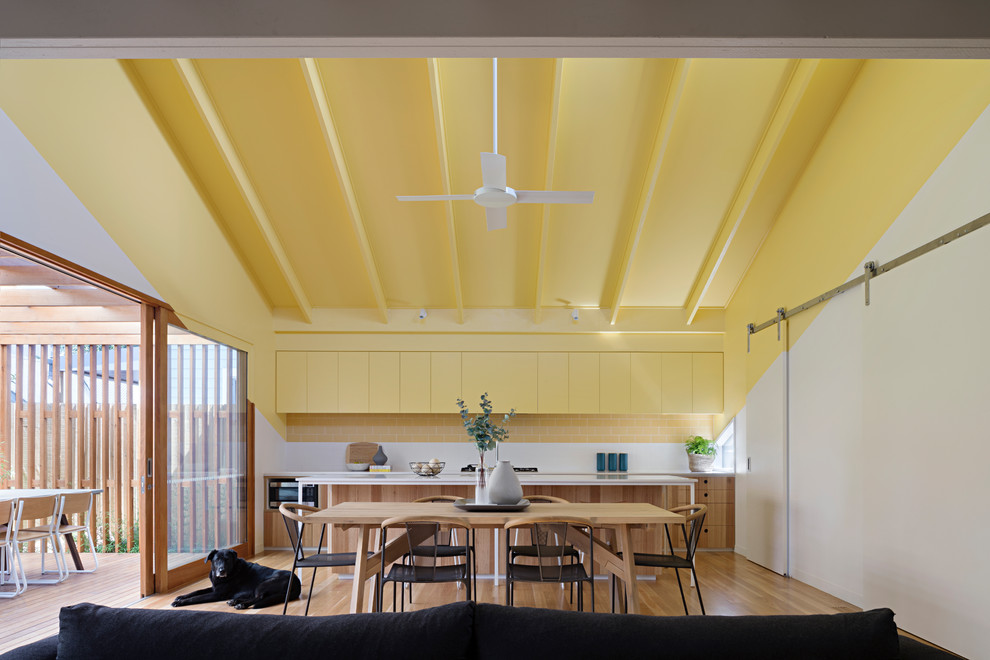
[764,102,990,657]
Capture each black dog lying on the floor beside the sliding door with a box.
[172,550,302,610]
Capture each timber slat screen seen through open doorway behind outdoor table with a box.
[0,344,141,552]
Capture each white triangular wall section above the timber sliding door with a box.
[0,110,162,300]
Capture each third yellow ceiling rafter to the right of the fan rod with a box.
[685,60,819,324]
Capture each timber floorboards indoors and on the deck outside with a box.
[0,551,859,653]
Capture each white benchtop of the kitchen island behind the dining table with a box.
[280,471,704,486]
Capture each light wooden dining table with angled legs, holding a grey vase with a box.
[306,502,684,614]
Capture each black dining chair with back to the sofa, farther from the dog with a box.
[505,516,595,612]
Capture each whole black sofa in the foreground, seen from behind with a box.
[0,602,952,660]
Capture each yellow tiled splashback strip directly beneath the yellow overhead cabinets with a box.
[287,413,713,444]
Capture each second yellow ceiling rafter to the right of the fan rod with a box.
[609,59,691,325]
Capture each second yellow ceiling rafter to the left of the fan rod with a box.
[300,57,388,323]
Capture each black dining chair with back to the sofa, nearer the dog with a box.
[376,516,474,612]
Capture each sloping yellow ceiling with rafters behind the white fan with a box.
[4,59,980,319]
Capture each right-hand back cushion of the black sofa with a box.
[474,603,898,660]
